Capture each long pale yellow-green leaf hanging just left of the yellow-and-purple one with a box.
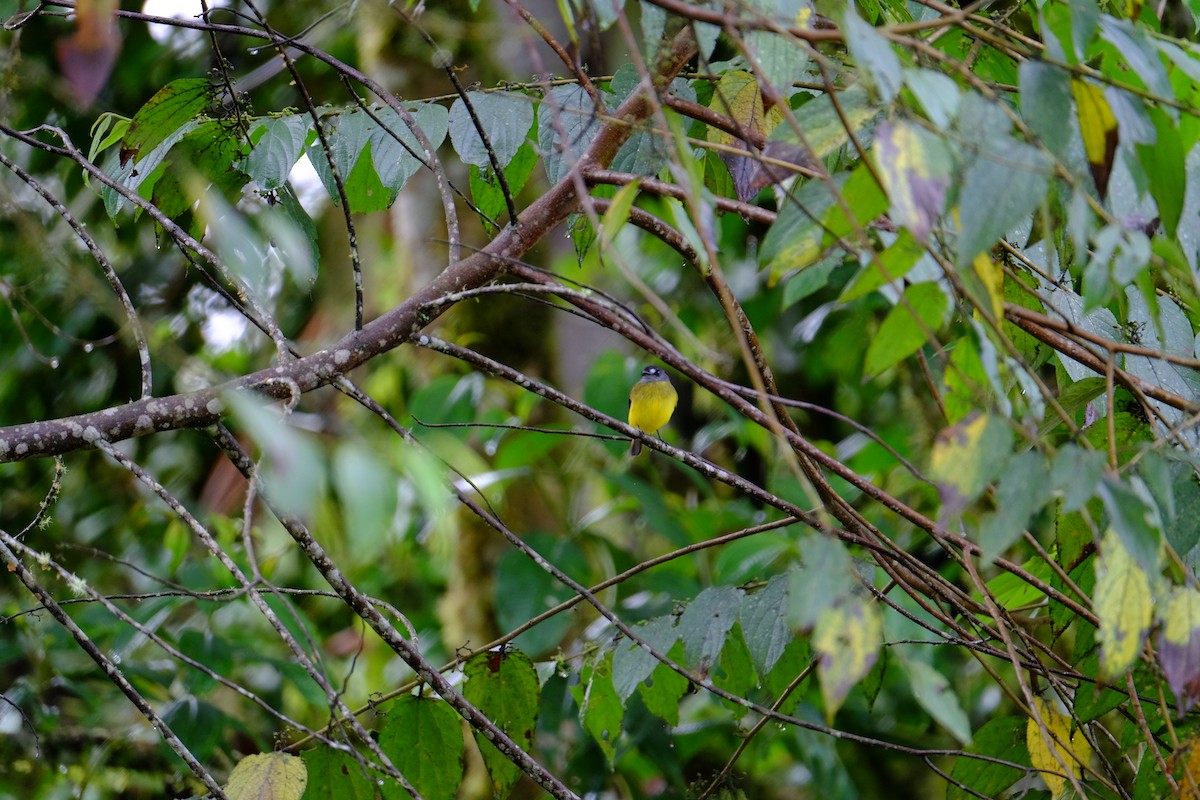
[1094,528,1154,678]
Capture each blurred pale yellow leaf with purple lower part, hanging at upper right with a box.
[875,120,954,241]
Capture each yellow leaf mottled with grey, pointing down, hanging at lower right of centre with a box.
[812,595,883,722]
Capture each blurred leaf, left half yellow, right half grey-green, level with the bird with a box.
[929,414,1013,515]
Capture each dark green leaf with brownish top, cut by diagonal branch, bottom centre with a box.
[463,649,540,798]
